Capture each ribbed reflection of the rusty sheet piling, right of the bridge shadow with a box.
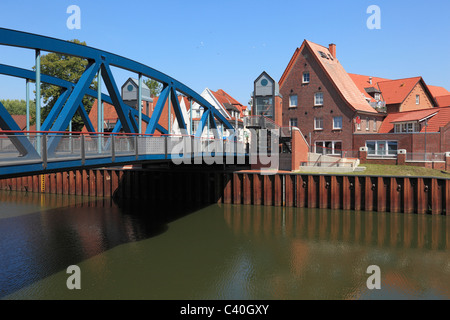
[224,205,450,250]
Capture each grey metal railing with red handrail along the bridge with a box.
[0,131,245,169]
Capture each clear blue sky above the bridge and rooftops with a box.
[0,0,450,105]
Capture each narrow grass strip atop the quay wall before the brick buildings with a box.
[348,163,450,178]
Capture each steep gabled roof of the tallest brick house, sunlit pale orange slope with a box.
[279,40,378,113]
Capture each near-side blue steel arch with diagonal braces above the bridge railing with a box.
[0,28,233,141]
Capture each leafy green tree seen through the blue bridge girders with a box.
[33,39,97,131]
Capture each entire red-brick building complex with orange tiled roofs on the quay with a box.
[279,40,450,159]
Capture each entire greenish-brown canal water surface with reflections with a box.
[0,192,450,300]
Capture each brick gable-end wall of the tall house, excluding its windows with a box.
[280,47,354,150]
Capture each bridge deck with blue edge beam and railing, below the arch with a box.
[0,133,245,177]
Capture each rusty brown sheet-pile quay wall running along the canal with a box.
[0,169,450,215]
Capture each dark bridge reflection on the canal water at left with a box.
[0,192,202,298]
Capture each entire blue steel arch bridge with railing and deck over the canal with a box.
[0,28,244,177]
